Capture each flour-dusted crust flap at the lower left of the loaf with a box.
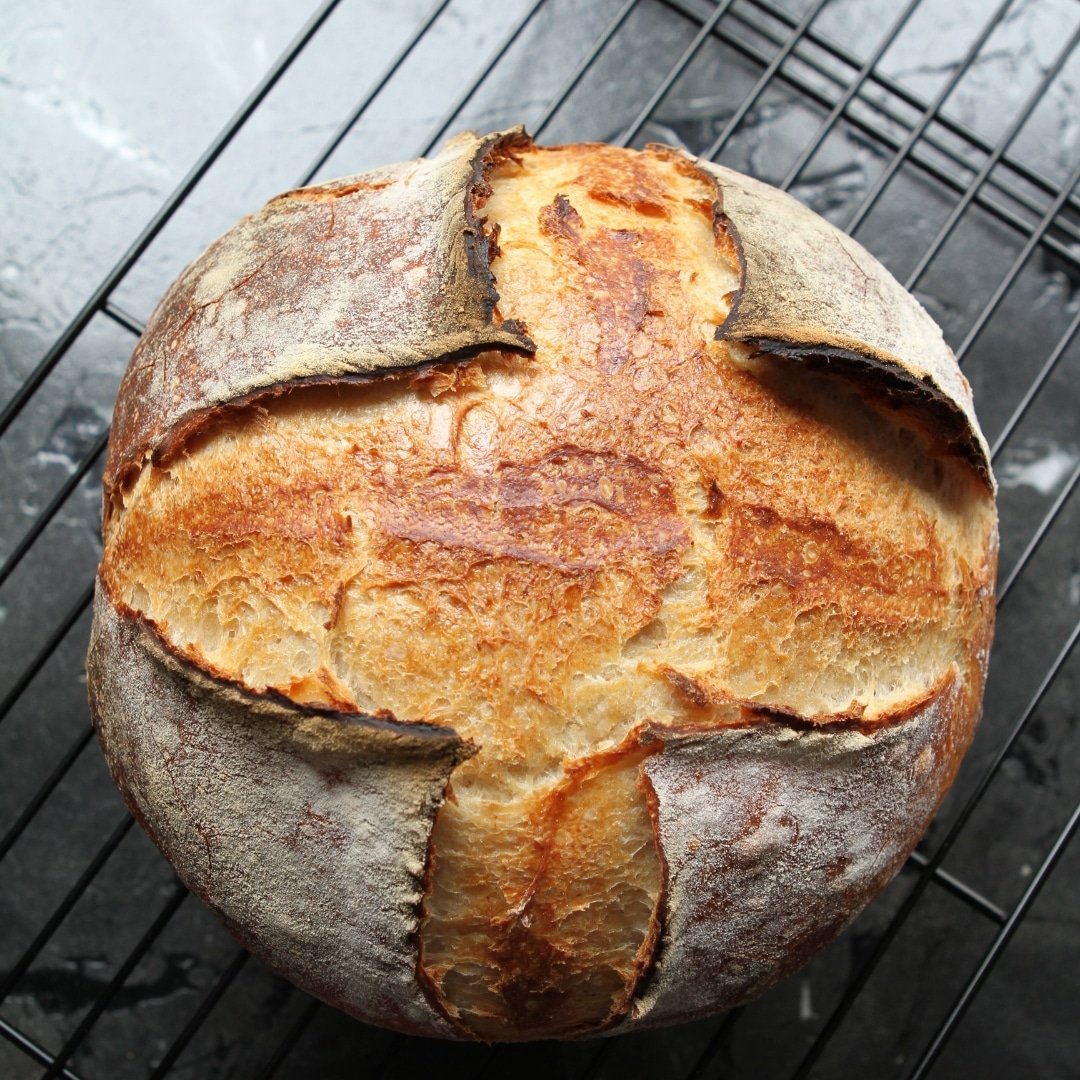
[86,585,469,1038]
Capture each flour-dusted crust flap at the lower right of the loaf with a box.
[633,672,971,1026]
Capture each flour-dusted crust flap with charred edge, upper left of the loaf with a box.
[104,127,532,502]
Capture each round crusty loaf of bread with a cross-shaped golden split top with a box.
[89,130,997,1040]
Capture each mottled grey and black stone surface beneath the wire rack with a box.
[0,0,1080,1080]
